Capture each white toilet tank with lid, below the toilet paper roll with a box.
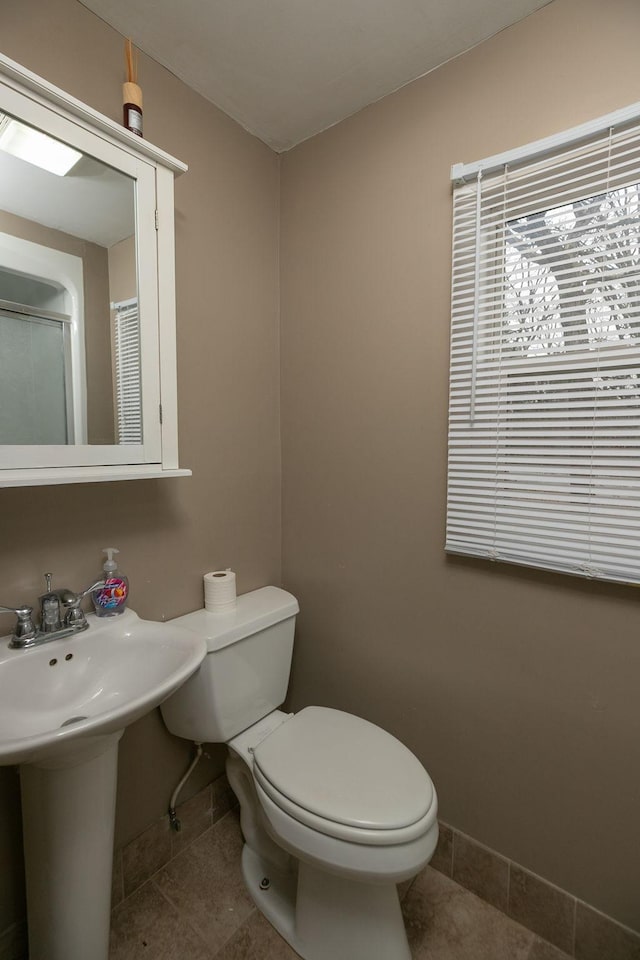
[160,587,299,743]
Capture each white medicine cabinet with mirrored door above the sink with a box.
[0,55,191,486]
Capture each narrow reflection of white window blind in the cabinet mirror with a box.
[112,299,142,443]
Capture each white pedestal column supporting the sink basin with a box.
[20,730,124,960]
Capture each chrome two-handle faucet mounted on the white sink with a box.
[0,573,105,650]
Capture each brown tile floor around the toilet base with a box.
[110,810,568,960]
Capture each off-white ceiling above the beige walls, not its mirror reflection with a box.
[82,0,551,152]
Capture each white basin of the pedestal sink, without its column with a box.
[0,610,206,765]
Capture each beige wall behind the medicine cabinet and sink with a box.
[0,0,280,931]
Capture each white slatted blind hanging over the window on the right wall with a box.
[446,113,640,583]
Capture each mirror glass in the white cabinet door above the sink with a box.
[0,113,143,445]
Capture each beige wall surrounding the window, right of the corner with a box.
[281,0,640,929]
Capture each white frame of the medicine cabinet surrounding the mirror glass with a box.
[0,54,191,487]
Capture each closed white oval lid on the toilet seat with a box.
[253,707,434,830]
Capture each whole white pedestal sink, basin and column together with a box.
[0,610,206,960]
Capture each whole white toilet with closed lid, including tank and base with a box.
[161,587,438,960]
